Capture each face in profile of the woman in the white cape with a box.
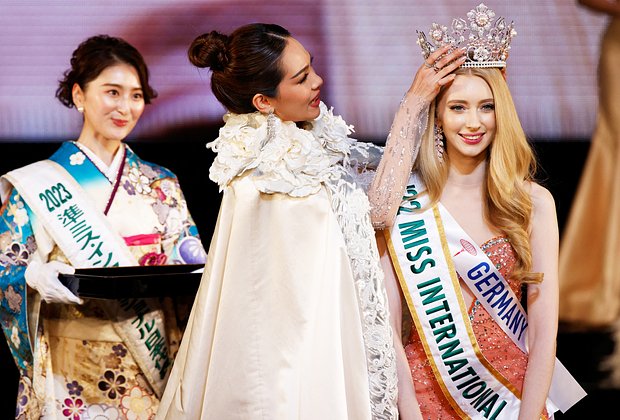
[269,37,323,122]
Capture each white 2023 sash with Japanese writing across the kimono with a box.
[1,160,172,396]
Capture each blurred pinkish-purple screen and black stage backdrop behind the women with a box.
[0,0,620,419]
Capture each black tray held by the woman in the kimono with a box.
[58,264,204,299]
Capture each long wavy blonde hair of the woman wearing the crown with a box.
[414,68,542,283]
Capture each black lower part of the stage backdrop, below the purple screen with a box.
[0,137,620,419]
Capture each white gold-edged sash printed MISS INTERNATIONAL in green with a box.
[386,205,520,419]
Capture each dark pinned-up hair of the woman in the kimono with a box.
[56,35,157,108]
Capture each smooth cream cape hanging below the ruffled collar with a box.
[157,176,371,420]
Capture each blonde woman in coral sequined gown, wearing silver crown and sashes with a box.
[369,4,584,419]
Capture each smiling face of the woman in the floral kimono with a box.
[73,63,144,146]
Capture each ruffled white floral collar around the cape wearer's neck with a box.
[207,102,353,197]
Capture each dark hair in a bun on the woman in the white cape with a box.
[188,23,291,114]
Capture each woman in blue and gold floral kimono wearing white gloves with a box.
[0,35,206,419]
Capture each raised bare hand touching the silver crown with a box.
[408,45,466,102]
